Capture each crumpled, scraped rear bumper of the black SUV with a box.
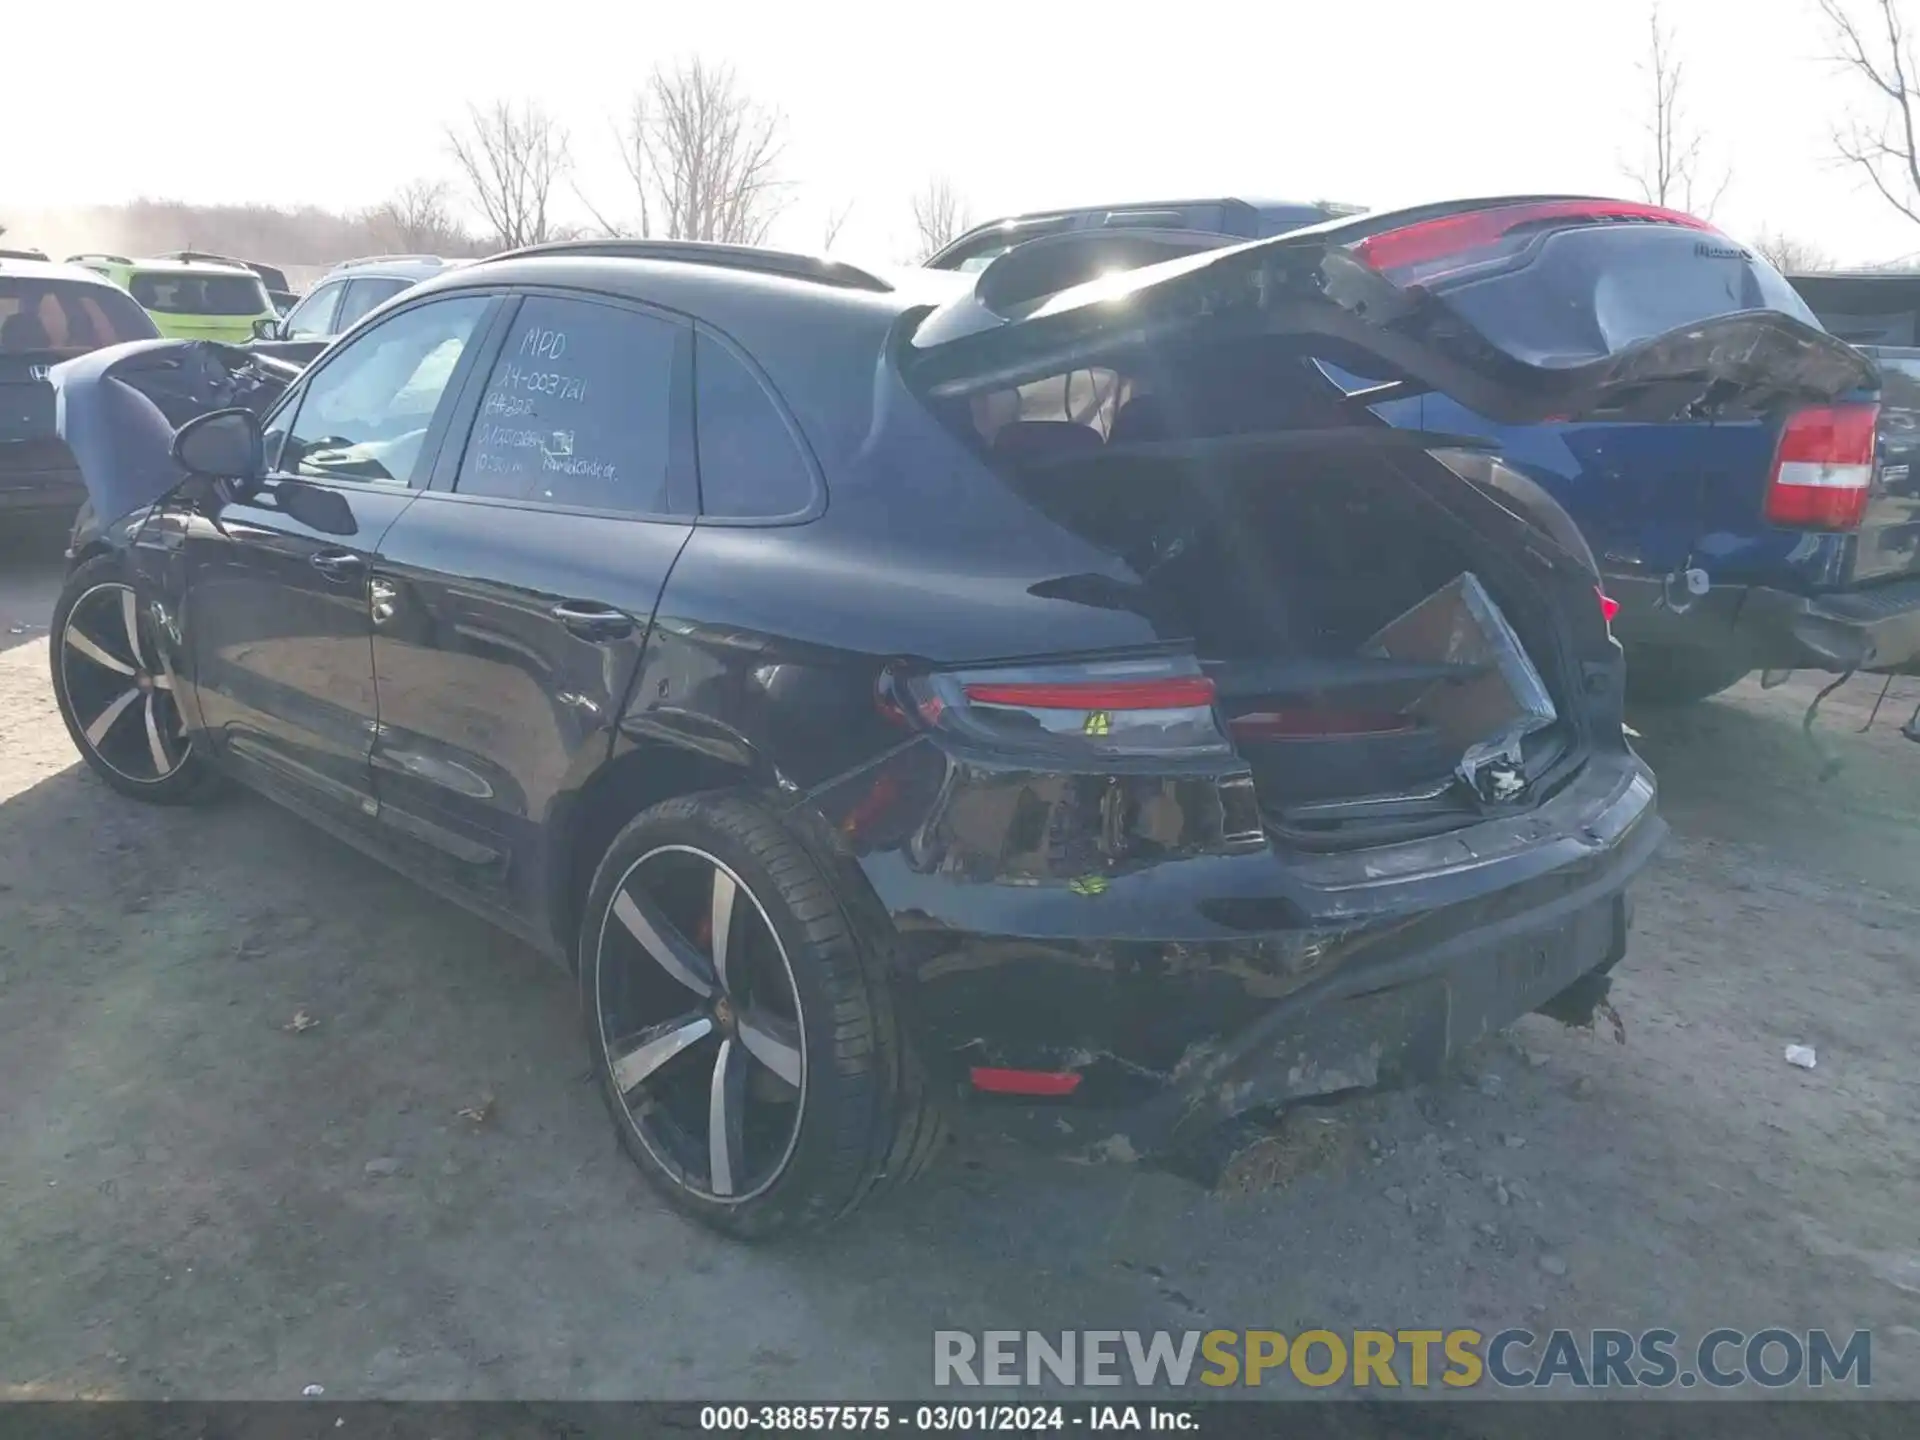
[828,745,1667,1154]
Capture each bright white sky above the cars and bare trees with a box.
[0,0,1920,261]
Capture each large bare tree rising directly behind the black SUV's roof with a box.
[620,60,787,246]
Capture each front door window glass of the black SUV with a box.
[278,296,492,486]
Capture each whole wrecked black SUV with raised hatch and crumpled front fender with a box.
[37,205,1859,1235]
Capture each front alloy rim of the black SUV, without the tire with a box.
[58,582,190,785]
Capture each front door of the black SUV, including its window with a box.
[184,296,493,824]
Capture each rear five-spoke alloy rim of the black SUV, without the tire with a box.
[593,845,806,1204]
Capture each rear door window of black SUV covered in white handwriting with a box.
[453,296,689,515]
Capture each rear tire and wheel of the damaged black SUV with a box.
[578,793,945,1238]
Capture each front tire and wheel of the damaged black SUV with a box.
[48,555,219,804]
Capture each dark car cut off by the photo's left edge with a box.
[0,250,159,524]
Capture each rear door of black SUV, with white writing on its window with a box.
[372,292,695,924]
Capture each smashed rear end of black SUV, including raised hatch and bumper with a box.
[839,198,1874,1175]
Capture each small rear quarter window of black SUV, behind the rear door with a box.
[693,334,814,520]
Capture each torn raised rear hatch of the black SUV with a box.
[904,198,1878,424]
